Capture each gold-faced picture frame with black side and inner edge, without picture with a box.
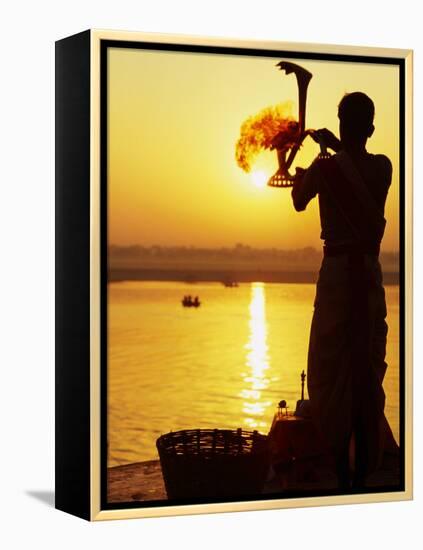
[56,30,413,521]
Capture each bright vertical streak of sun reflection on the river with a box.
[240,283,271,429]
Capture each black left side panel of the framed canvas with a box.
[55,31,90,519]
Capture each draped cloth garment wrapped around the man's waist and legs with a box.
[307,254,388,473]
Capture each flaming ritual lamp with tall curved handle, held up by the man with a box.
[236,61,313,188]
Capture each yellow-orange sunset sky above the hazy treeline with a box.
[108,48,399,250]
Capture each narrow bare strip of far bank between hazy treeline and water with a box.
[109,268,399,285]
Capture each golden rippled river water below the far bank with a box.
[108,282,399,466]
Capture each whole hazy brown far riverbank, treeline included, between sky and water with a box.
[108,244,398,284]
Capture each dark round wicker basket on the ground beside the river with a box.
[156,428,269,499]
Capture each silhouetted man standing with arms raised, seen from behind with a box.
[292,92,392,490]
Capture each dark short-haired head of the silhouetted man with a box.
[338,92,375,145]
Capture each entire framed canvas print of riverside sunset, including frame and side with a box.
[56,30,412,520]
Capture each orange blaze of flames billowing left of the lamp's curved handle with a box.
[235,102,298,172]
